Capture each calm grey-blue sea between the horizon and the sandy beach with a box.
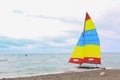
[0,53,120,78]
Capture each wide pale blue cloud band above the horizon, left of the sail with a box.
[0,36,73,54]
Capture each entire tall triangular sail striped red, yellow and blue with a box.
[69,12,101,64]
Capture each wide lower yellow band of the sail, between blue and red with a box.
[71,45,101,59]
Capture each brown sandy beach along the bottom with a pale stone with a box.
[0,69,120,80]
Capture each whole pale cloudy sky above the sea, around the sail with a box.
[0,0,120,54]
